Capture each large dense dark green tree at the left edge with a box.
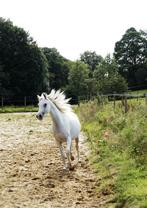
[0,18,48,98]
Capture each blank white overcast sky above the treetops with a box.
[0,0,147,61]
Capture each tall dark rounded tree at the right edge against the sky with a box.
[114,28,147,86]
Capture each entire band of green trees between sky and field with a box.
[0,18,147,103]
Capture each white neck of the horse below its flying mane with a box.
[50,101,61,125]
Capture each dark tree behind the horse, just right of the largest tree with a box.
[42,48,69,89]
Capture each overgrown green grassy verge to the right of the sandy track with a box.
[78,101,147,208]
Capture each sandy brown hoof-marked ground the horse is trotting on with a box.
[0,113,108,208]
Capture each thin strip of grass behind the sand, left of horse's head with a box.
[0,106,38,113]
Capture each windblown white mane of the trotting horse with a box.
[47,89,72,112]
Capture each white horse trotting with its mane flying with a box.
[36,90,81,169]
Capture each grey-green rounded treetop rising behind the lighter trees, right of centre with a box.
[80,51,103,74]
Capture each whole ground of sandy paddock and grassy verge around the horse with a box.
[0,99,147,208]
